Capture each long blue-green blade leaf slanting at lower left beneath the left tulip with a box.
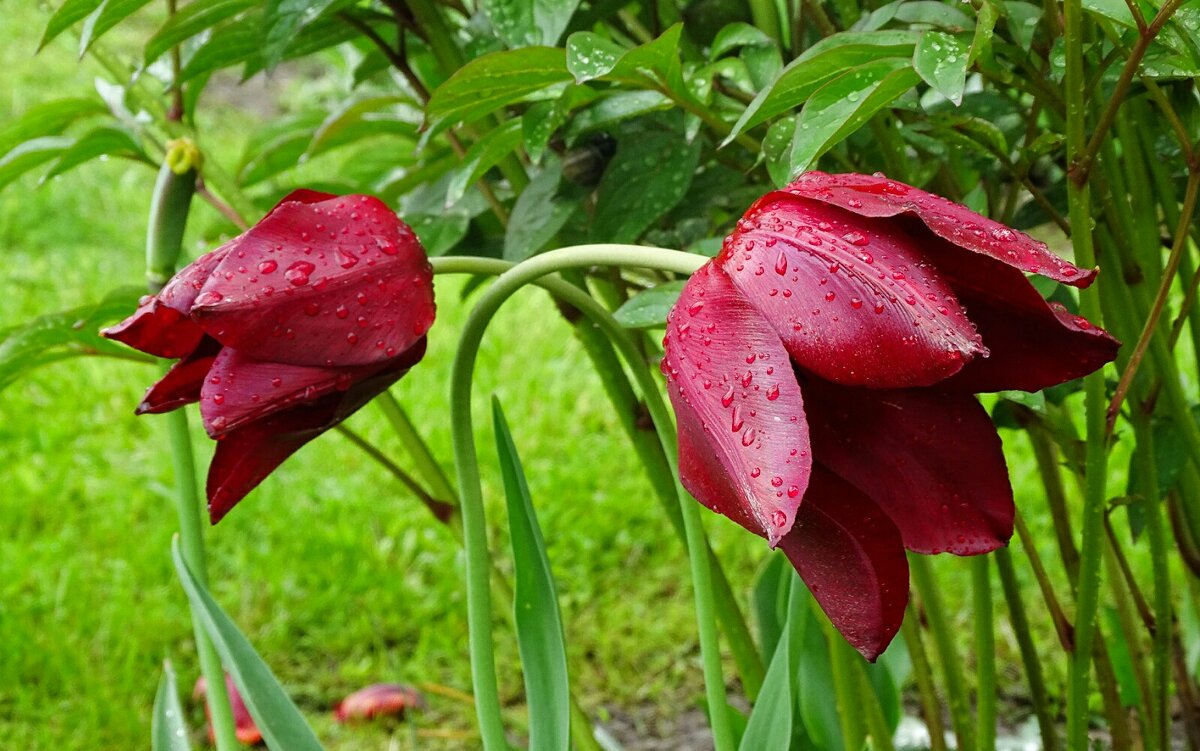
[170,535,322,751]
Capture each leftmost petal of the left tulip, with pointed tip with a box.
[101,241,235,359]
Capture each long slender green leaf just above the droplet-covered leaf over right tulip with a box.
[721,31,920,145]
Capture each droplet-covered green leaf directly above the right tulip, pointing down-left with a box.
[790,59,919,179]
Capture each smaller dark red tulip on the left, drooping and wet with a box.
[103,191,434,523]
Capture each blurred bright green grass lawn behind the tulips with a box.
[0,0,1122,751]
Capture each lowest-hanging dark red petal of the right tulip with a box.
[780,467,908,662]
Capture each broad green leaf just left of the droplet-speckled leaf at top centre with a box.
[425,47,571,137]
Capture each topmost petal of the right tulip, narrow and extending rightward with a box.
[784,172,1096,287]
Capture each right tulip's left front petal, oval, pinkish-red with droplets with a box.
[662,263,812,546]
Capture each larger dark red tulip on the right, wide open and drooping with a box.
[662,172,1120,660]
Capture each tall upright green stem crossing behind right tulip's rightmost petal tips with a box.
[1062,0,1108,751]
